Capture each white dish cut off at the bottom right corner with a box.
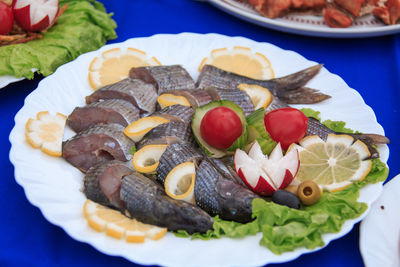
[360,175,400,267]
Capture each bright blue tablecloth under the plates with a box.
[0,0,400,267]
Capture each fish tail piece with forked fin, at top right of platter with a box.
[197,64,330,104]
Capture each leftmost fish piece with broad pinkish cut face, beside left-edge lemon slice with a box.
[62,123,134,172]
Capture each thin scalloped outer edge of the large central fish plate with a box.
[9,32,389,265]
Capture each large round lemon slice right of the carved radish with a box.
[289,134,372,192]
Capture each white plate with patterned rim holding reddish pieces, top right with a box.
[206,0,400,38]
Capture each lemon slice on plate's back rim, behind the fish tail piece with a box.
[199,46,275,80]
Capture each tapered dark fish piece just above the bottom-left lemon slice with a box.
[121,172,213,234]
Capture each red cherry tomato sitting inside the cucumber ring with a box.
[200,107,242,149]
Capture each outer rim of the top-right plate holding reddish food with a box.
[205,0,400,38]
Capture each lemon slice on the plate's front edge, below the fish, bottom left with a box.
[83,199,167,243]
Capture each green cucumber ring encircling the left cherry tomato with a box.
[192,100,248,158]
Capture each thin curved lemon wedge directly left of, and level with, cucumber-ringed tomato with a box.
[124,116,169,142]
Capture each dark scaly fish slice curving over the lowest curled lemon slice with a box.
[157,143,203,184]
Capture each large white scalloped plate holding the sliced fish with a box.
[10,33,389,266]
